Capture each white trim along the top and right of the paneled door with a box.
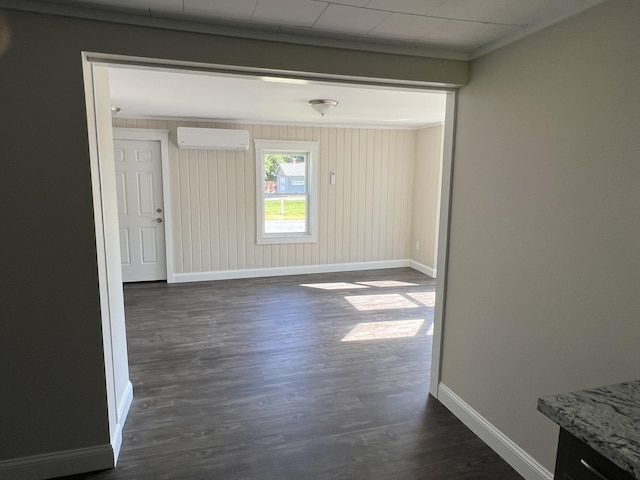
[113,128,176,283]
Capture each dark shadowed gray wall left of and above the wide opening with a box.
[0,6,468,461]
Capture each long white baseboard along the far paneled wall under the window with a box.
[174,260,409,283]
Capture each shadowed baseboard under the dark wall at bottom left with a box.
[0,445,114,480]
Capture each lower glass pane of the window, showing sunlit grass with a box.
[264,195,307,233]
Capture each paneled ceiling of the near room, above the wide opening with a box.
[26,0,604,60]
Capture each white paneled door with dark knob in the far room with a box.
[114,140,167,282]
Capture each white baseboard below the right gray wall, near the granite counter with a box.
[438,383,553,480]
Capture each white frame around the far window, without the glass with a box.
[254,139,320,245]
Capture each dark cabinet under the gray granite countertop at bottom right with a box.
[554,428,635,480]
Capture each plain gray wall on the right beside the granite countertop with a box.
[442,0,640,468]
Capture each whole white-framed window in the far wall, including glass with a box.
[255,140,318,244]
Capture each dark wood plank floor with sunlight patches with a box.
[60,269,521,480]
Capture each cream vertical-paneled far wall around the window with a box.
[114,119,416,274]
